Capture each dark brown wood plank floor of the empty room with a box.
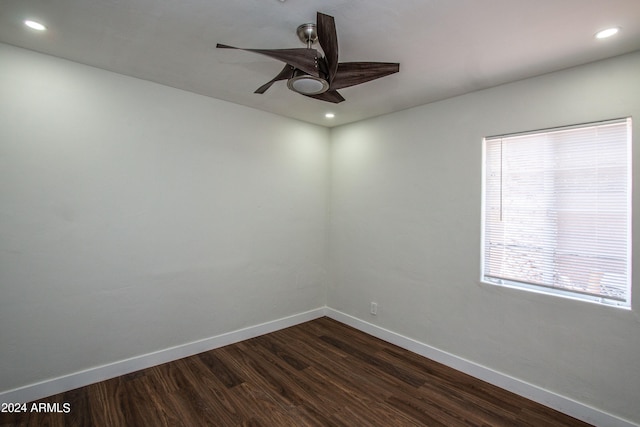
[0,318,588,427]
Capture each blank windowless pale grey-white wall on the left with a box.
[0,44,329,392]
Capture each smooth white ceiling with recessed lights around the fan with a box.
[0,0,640,126]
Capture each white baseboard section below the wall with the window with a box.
[326,307,637,427]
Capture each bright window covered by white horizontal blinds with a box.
[482,118,631,307]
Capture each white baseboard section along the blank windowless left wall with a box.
[0,307,326,402]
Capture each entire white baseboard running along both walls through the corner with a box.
[0,307,637,427]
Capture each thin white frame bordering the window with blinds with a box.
[480,118,632,309]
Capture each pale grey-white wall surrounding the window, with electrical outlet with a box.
[327,53,640,423]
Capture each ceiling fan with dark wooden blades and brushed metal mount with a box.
[216,12,400,104]
